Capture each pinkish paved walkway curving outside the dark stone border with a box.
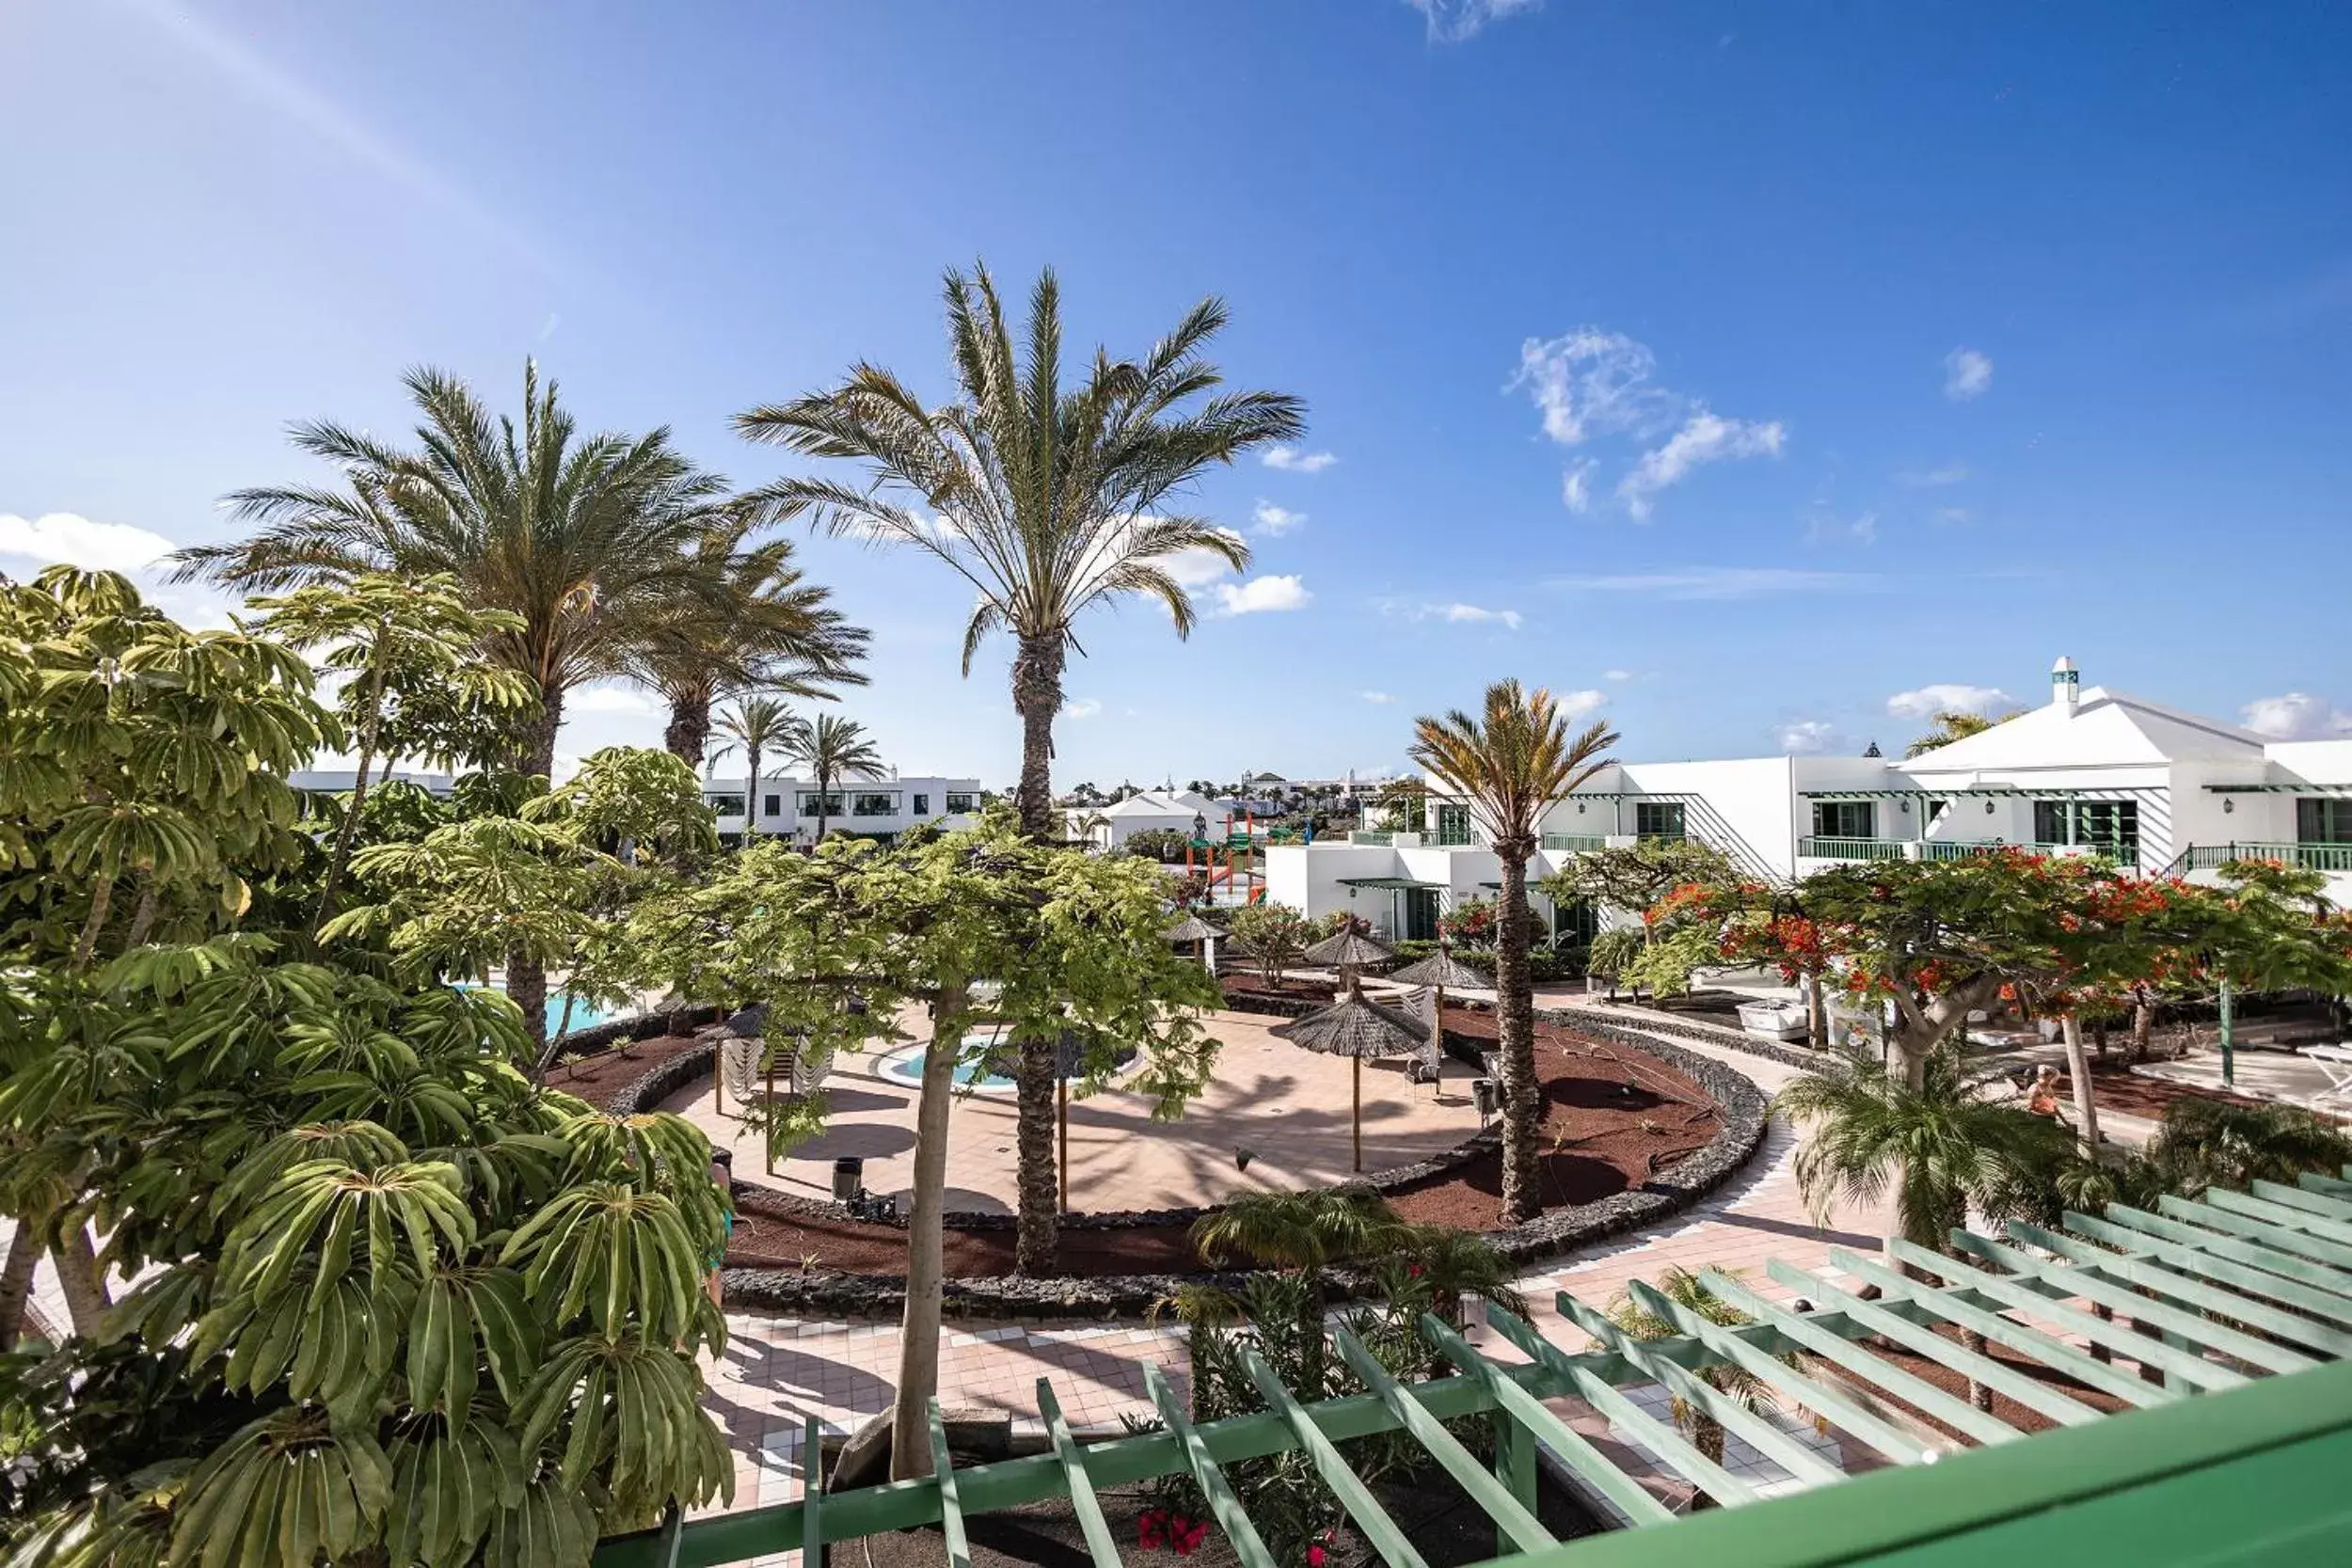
[713,1020,1910,1563]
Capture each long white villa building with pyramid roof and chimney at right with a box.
[1265,658,2352,938]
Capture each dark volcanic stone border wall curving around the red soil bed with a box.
[710,1008,1772,1319]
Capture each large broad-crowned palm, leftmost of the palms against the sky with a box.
[172,362,765,1044]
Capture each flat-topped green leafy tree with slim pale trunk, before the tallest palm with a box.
[630,814,1216,1477]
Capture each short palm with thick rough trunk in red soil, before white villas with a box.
[1411,679,1618,1225]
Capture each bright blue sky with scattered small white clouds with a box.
[0,0,2352,785]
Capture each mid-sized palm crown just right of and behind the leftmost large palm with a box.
[626,538,868,771]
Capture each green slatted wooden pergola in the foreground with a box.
[597,1168,2352,1568]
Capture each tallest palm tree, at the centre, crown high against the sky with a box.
[737,268,1306,1272]
